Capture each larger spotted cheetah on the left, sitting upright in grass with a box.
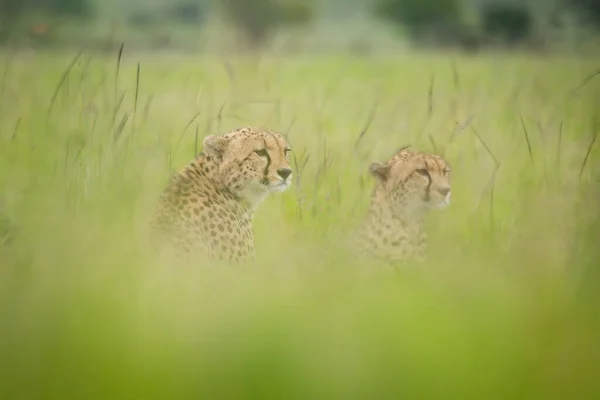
[152,126,292,263]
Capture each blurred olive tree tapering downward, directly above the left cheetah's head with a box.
[219,0,314,48]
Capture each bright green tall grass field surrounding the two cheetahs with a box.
[0,48,600,400]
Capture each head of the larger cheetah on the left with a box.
[203,127,292,204]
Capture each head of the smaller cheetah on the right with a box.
[369,147,451,214]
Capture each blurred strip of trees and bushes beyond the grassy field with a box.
[0,0,600,54]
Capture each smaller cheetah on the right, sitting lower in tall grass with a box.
[351,146,451,265]
